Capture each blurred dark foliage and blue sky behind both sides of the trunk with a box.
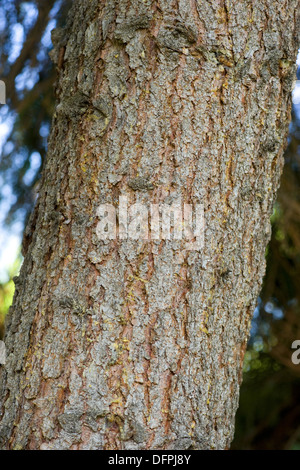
[0,0,300,450]
